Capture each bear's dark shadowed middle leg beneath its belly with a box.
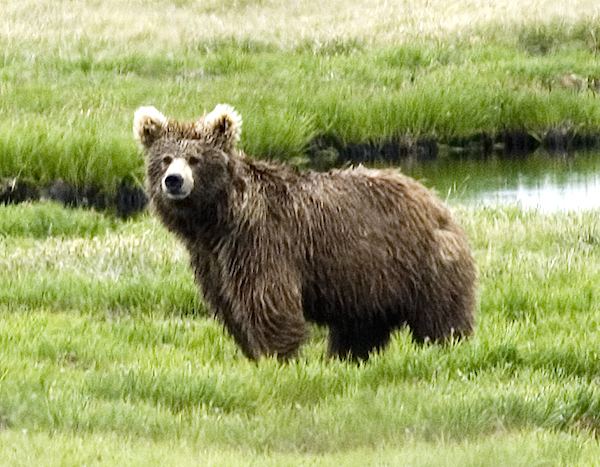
[328,323,391,361]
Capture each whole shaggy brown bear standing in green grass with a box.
[133,104,476,361]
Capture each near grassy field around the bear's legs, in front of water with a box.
[0,204,600,466]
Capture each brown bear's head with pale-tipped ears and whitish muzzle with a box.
[133,104,242,215]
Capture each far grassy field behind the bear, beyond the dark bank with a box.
[0,0,600,192]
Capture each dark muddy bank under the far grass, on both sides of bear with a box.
[0,128,600,218]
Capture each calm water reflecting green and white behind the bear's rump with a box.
[402,153,600,212]
